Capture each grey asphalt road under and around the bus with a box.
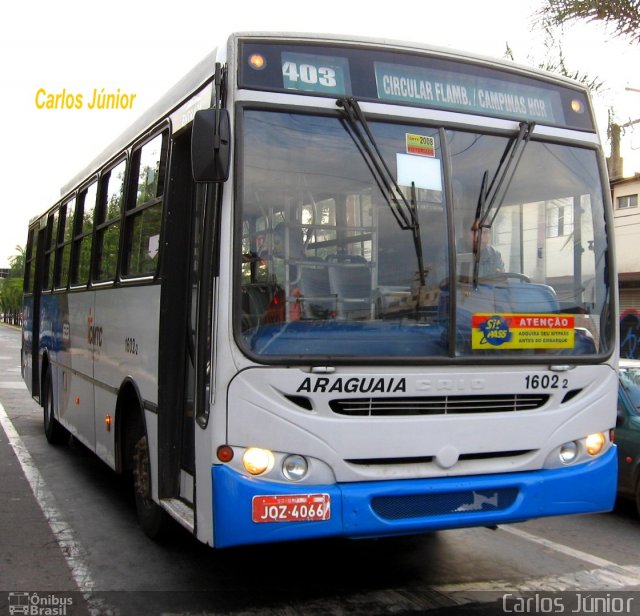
[0,327,640,616]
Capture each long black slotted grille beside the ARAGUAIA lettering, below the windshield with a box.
[329,394,549,417]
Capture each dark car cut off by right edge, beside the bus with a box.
[615,359,640,516]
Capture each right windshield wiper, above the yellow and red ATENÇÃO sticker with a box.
[471,122,535,289]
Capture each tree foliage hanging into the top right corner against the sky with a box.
[539,0,640,44]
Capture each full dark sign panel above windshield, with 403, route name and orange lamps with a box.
[238,40,595,131]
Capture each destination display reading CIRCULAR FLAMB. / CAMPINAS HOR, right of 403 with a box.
[375,62,564,124]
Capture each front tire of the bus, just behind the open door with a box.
[133,421,170,539]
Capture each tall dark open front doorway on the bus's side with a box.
[158,129,199,505]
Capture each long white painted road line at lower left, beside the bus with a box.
[0,403,112,613]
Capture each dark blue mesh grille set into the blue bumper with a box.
[371,488,518,520]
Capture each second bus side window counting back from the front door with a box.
[94,160,127,282]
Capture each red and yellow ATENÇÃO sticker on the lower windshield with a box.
[471,314,575,350]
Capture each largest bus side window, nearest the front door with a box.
[123,131,169,276]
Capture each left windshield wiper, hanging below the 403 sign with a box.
[337,97,426,292]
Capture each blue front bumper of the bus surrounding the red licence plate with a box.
[211,447,617,547]
